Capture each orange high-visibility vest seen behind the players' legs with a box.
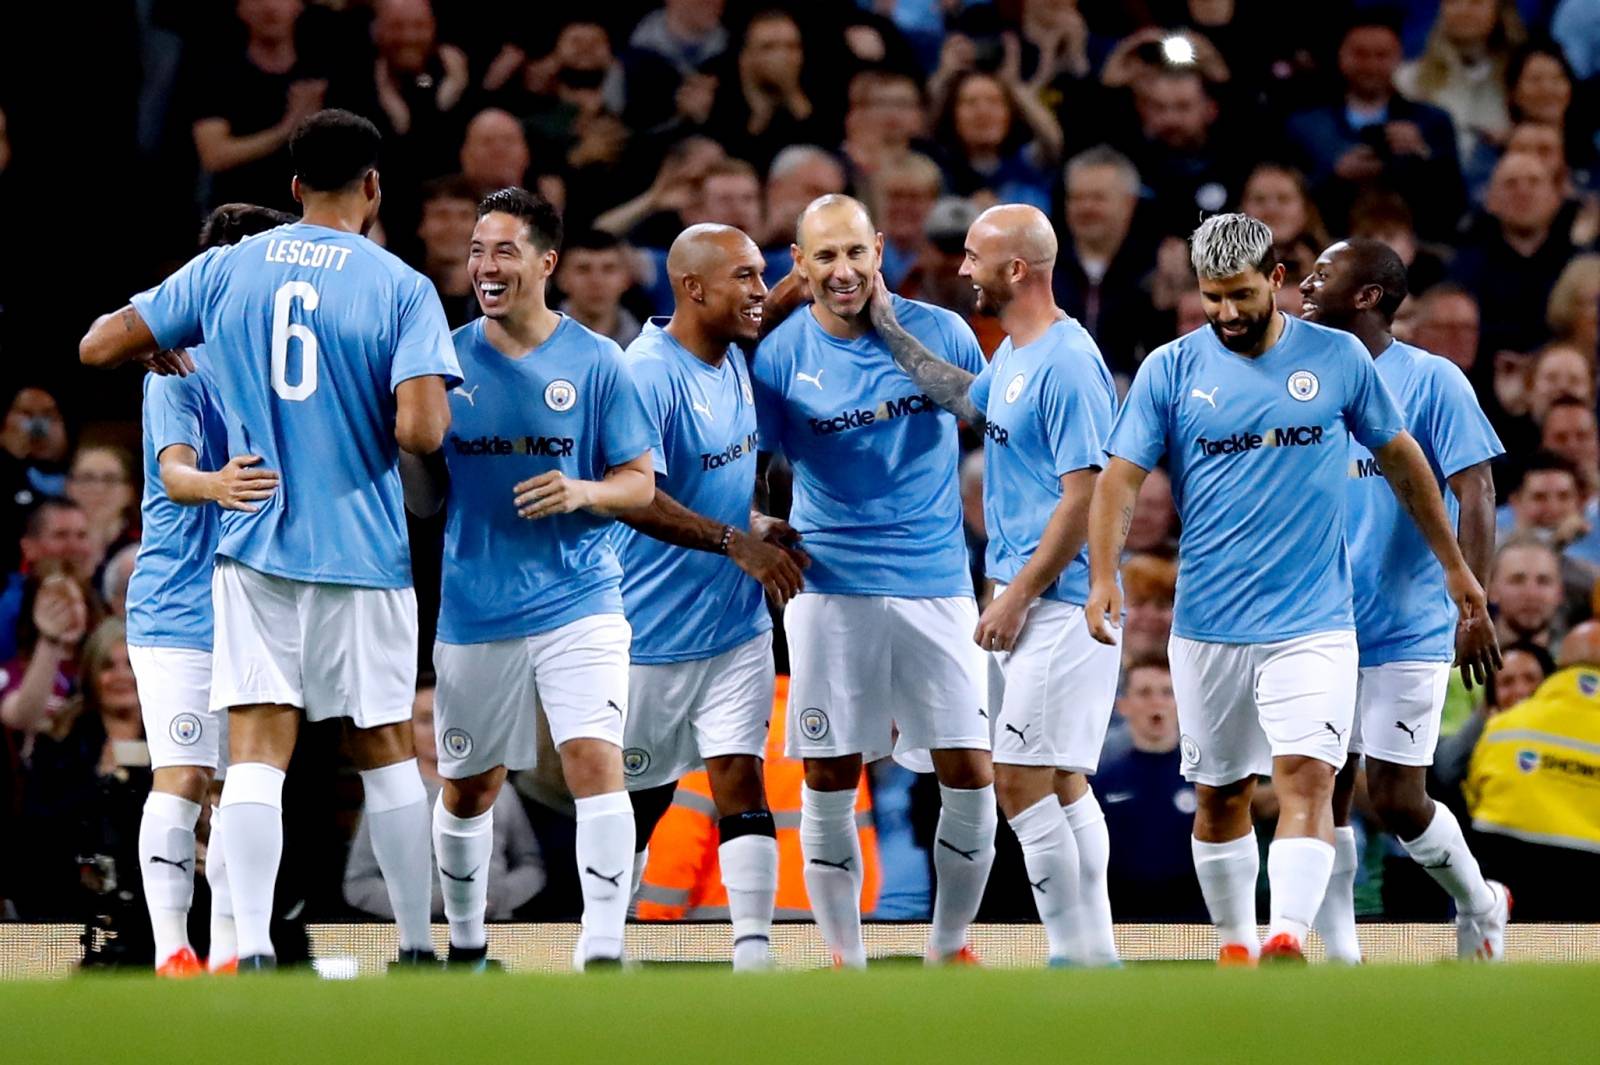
[637,676,882,921]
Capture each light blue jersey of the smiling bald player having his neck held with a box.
[750,296,984,598]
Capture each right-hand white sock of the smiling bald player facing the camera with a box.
[928,784,1000,958]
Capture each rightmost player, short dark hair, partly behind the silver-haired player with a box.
[1301,237,1510,963]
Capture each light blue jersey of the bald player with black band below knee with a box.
[616,318,773,664]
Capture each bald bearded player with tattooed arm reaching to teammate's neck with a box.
[870,205,1118,966]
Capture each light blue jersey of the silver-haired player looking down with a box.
[1106,315,1405,643]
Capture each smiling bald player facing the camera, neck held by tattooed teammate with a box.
[752,195,997,967]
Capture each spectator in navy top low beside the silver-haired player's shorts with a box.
[1094,656,1206,923]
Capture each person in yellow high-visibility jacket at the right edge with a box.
[1464,622,1600,921]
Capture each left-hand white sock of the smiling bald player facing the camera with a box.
[800,784,867,969]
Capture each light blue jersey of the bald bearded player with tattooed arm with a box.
[970,318,1117,606]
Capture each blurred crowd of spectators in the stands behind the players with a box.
[0,0,1600,946]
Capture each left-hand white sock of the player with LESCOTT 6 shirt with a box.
[222,761,283,958]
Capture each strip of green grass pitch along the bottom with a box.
[0,964,1600,1065]
